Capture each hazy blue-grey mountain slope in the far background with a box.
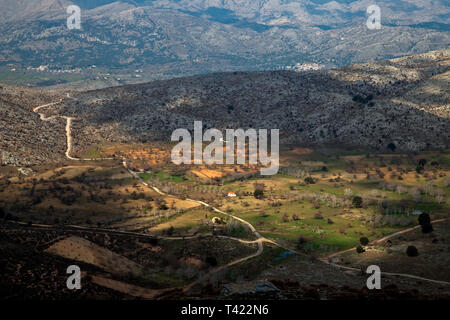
[0,0,450,78]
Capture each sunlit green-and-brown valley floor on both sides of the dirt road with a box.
[0,144,450,253]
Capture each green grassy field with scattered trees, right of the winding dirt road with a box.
[134,146,450,252]
